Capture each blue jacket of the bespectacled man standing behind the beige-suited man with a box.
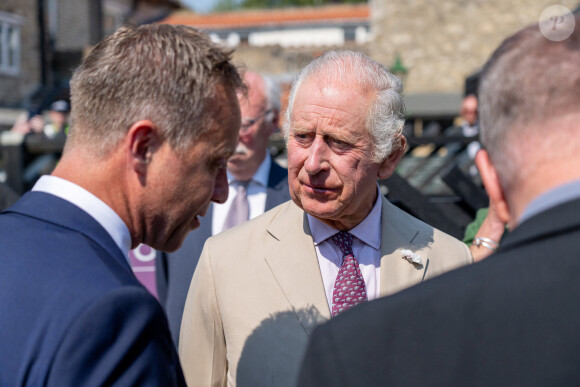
[155,160,290,346]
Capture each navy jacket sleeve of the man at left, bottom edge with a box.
[46,287,185,386]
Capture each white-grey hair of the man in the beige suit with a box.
[282,51,405,162]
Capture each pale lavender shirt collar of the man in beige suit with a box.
[306,184,382,250]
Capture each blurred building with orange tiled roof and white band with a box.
[162,4,370,83]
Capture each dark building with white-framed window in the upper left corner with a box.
[0,0,182,113]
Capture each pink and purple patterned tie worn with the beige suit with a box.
[332,231,367,317]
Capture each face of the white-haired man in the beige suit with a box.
[288,79,386,230]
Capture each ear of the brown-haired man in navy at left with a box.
[127,120,163,175]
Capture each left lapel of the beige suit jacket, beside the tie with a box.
[266,202,330,335]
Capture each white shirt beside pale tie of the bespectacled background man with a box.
[211,151,272,235]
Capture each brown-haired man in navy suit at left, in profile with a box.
[0,25,244,386]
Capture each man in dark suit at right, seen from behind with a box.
[299,13,580,387]
